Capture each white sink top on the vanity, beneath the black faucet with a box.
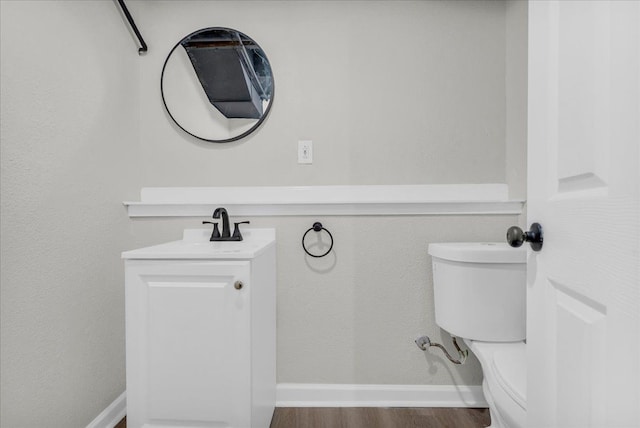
[122,228,276,260]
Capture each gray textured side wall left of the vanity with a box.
[0,1,139,428]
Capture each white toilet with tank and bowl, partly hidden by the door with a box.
[429,242,527,428]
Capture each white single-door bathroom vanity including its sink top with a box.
[123,229,276,428]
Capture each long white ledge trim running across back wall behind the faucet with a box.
[124,184,524,217]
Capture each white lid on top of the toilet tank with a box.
[429,242,527,263]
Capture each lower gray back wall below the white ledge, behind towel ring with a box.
[133,216,517,385]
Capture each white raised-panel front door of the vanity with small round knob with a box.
[126,261,251,428]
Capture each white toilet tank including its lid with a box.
[429,242,527,342]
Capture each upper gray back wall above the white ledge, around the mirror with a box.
[132,1,506,186]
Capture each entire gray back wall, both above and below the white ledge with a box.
[133,1,526,384]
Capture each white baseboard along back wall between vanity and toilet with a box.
[276,383,488,407]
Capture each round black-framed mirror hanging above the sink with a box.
[160,27,273,143]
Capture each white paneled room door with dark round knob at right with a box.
[527,0,640,428]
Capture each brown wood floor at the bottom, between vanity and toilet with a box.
[115,407,490,428]
